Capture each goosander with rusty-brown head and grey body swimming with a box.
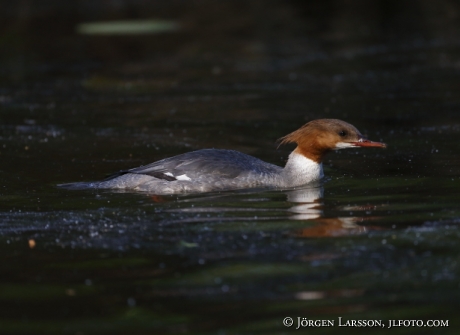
[59,119,386,195]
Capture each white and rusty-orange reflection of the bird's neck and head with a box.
[287,184,382,237]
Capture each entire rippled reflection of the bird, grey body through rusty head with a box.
[149,183,382,237]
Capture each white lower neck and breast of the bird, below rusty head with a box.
[283,152,324,187]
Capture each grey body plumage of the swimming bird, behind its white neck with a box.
[60,149,298,194]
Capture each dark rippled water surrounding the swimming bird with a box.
[0,1,460,334]
